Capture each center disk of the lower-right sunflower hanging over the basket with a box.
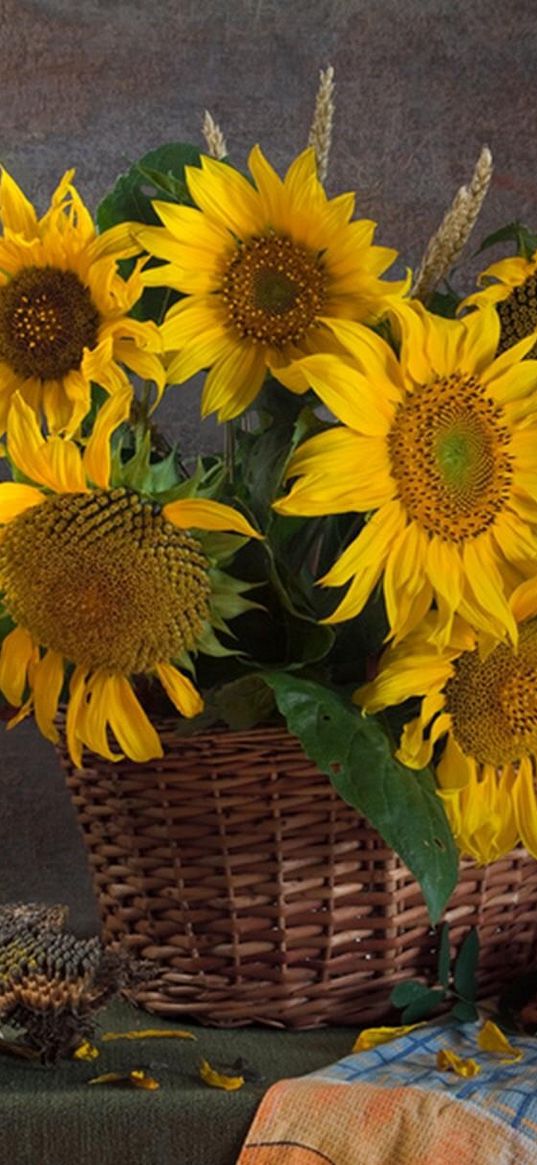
[446,620,537,767]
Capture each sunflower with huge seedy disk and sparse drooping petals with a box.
[0,396,260,765]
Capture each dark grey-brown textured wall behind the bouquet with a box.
[0,0,537,930]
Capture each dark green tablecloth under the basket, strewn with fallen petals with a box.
[0,1004,356,1165]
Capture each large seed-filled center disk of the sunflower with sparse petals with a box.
[0,489,211,675]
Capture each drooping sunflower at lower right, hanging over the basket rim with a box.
[354,591,537,863]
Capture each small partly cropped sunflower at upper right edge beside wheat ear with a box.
[459,250,537,356]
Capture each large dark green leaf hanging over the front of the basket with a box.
[266,672,458,922]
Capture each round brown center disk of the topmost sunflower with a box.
[218,234,326,347]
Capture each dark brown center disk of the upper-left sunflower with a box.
[0,267,99,380]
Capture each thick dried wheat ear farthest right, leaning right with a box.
[411,146,493,302]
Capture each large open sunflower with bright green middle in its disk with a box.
[275,304,537,644]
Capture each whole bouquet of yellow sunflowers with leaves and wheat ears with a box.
[0,70,537,917]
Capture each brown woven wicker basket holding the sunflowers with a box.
[56,722,537,1028]
